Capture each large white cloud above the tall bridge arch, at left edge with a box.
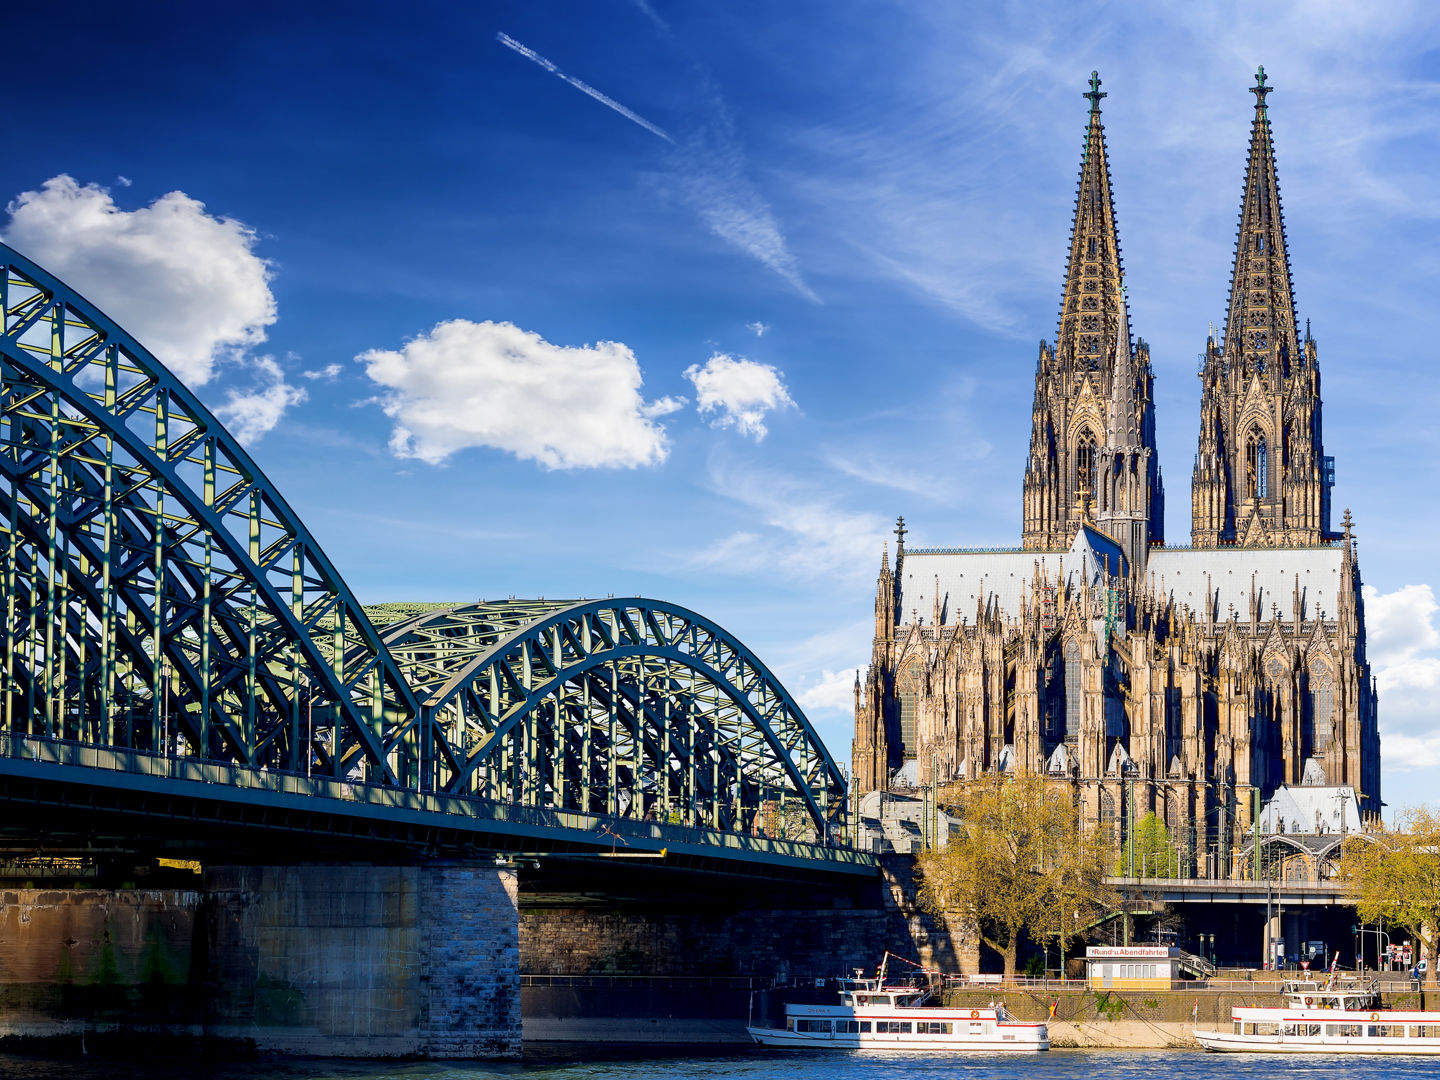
[3,176,275,386]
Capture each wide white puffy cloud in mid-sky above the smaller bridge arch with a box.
[356,320,684,469]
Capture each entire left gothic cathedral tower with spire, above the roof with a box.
[1021,72,1165,573]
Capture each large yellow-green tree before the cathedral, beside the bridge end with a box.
[919,773,1117,975]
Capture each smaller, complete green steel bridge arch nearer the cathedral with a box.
[384,598,845,838]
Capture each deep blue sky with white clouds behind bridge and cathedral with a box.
[0,0,1440,805]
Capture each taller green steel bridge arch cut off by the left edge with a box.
[0,246,425,785]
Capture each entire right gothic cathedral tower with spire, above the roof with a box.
[1191,68,1335,547]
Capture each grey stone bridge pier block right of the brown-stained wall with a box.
[204,863,520,1058]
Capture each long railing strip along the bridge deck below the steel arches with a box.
[0,732,873,865]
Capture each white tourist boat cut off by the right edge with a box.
[1195,975,1440,1054]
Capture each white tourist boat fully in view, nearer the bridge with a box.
[746,953,1050,1053]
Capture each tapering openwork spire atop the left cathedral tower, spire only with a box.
[1056,72,1123,370]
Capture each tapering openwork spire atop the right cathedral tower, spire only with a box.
[1224,68,1302,377]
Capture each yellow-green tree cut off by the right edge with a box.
[1339,806,1440,984]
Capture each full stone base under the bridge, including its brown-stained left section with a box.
[0,864,520,1057]
